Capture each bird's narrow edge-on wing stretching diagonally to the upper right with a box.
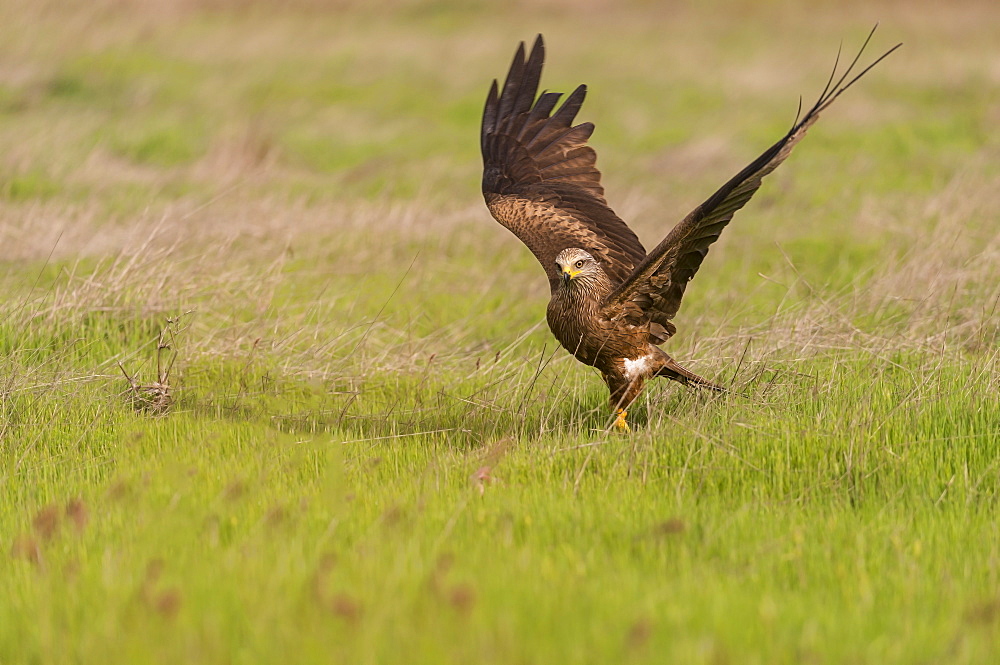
[604,26,901,343]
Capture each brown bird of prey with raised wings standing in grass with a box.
[480,29,900,431]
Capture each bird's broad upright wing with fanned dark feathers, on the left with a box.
[480,35,646,288]
